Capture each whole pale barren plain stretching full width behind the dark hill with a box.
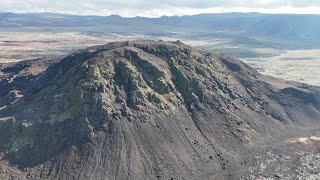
[0,31,320,86]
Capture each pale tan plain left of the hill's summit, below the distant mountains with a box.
[0,32,144,63]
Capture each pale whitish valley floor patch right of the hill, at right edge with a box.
[242,49,320,86]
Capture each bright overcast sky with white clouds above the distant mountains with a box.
[0,0,320,17]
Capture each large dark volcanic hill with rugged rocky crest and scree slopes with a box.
[0,41,320,179]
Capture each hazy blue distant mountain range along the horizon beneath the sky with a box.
[0,13,320,41]
